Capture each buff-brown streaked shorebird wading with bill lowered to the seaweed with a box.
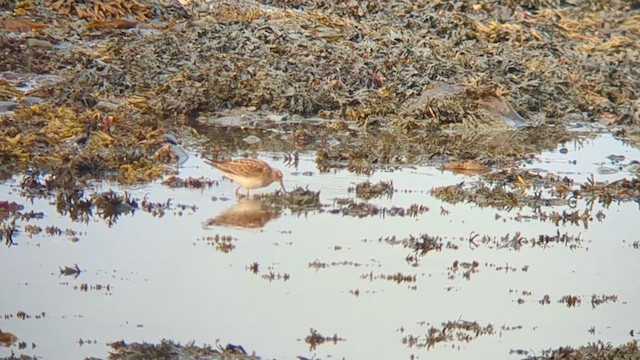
[205,159,286,197]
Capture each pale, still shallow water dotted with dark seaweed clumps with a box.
[0,135,640,359]
